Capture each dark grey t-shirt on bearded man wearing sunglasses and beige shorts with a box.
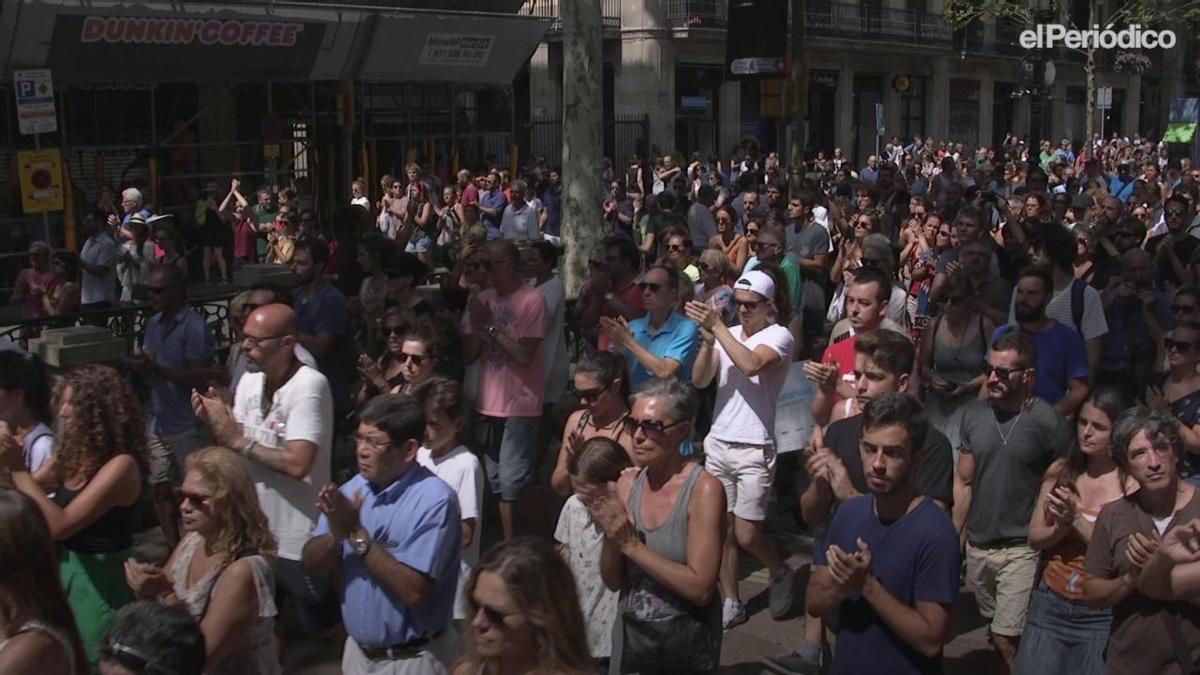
[959,399,1070,546]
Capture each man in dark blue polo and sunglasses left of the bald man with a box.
[130,264,216,466]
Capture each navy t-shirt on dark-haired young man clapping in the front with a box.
[812,495,959,675]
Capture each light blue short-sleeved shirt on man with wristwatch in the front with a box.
[313,464,462,647]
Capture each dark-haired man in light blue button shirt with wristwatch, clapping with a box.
[304,395,462,675]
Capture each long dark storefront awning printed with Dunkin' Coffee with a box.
[0,0,548,85]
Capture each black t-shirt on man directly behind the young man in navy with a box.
[824,414,954,507]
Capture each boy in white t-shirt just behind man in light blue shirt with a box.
[416,377,484,638]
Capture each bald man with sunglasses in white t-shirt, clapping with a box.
[192,304,337,637]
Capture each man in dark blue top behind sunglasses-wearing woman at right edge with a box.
[1094,249,1175,401]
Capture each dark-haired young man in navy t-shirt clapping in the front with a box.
[808,393,959,675]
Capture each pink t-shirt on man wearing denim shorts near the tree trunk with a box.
[468,286,546,417]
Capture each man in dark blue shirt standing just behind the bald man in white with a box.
[292,239,355,420]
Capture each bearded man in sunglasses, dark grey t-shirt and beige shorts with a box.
[954,329,1086,671]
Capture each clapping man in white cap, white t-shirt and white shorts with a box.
[686,270,796,629]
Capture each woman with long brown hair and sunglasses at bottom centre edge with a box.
[454,537,595,675]
